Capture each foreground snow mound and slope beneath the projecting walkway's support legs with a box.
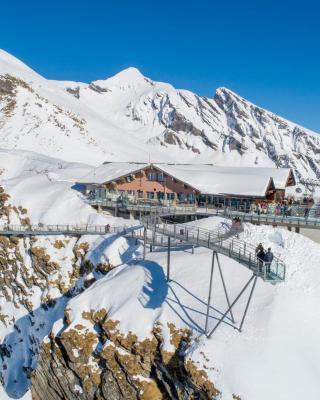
[62,218,320,400]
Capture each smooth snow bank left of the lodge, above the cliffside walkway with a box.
[0,150,137,226]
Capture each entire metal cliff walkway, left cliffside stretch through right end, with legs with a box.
[0,208,286,338]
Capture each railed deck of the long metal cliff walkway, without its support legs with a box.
[0,216,286,283]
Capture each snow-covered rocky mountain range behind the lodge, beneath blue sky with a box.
[0,51,320,184]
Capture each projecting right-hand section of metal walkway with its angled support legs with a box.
[140,215,286,338]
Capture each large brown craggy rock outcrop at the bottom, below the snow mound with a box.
[32,310,219,400]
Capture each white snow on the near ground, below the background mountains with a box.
[0,151,320,400]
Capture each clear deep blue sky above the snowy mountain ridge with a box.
[0,0,320,132]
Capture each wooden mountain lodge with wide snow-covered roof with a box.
[79,162,296,205]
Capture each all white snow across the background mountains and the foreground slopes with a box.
[0,50,320,400]
